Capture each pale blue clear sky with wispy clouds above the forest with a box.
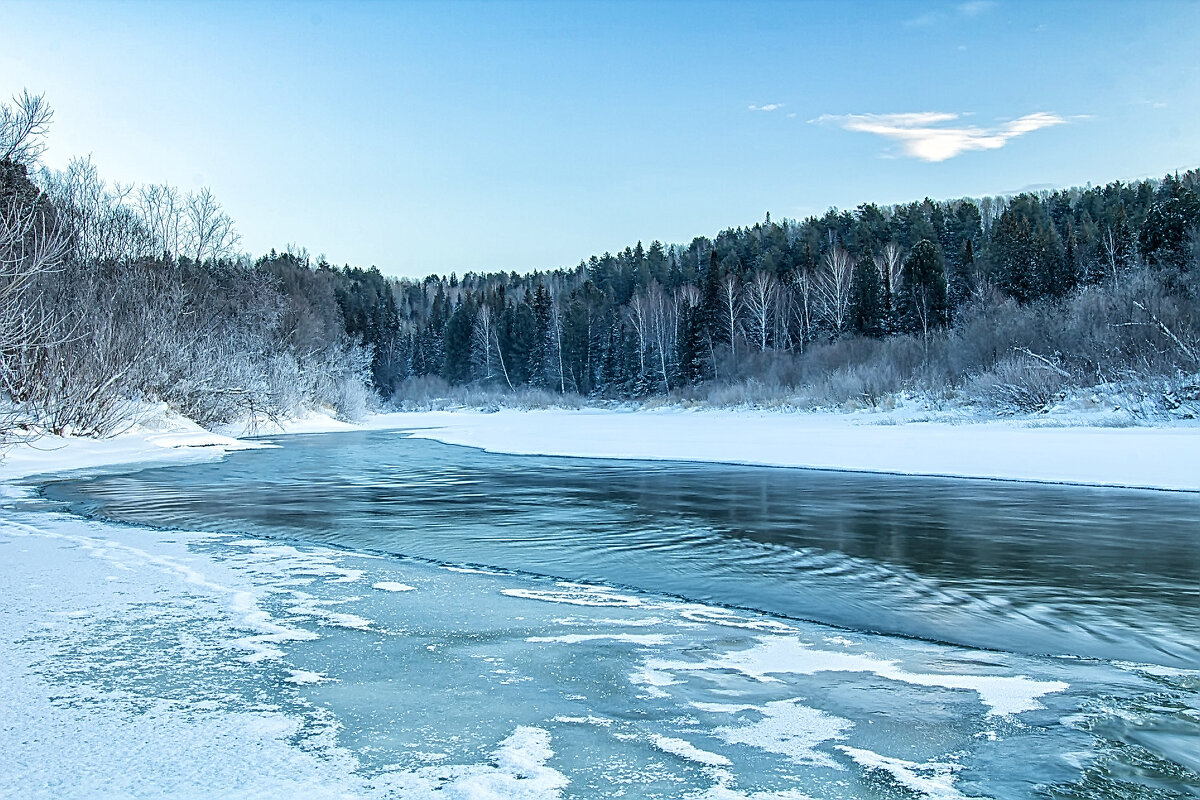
[0,0,1200,277]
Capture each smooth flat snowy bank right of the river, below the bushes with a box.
[338,409,1200,492]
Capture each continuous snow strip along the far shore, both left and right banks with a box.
[9,409,1200,492]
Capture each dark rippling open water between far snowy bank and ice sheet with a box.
[47,432,1200,667]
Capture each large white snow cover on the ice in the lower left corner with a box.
[0,510,568,800]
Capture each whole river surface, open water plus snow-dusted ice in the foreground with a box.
[9,432,1200,800]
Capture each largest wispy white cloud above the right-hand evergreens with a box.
[816,112,1067,162]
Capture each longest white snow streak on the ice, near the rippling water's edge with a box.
[656,637,1069,715]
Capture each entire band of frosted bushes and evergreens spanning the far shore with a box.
[0,92,1200,437]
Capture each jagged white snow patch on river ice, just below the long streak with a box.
[713,699,854,769]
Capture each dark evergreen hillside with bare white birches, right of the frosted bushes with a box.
[331,164,1200,412]
